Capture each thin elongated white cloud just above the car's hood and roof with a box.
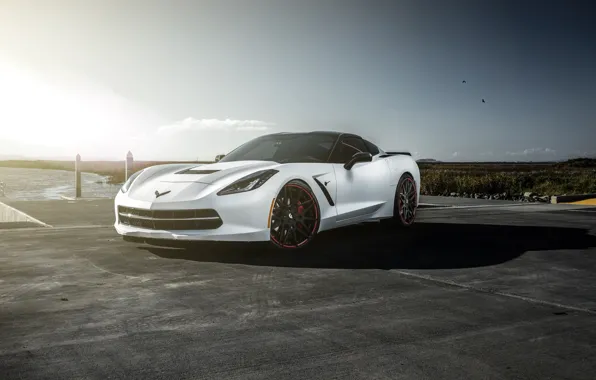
[158,117,275,134]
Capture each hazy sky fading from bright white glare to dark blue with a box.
[0,0,596,161]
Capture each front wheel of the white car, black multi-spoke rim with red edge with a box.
[271,184,319,248]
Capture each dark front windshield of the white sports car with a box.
[220,133,336,163]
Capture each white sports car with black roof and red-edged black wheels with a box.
[114,131,420,248]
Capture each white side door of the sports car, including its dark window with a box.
[330,135,391,224]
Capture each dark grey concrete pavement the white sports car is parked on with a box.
[0,198,596,380]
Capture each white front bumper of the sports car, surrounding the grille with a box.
[114,186,277,242]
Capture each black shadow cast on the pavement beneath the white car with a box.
[134,222,596,270]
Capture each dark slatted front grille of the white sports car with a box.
[118,206,223,231]
